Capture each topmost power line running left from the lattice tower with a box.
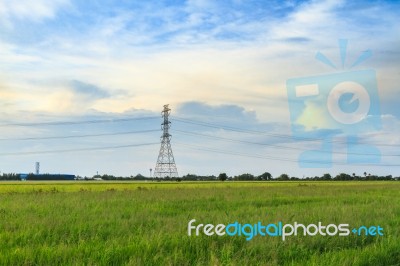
[0,116,159,127]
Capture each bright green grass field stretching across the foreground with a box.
[0,181,400,265]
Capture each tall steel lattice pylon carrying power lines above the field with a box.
[154,104,179,178]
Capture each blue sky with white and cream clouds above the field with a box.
[0,0,400,177]
